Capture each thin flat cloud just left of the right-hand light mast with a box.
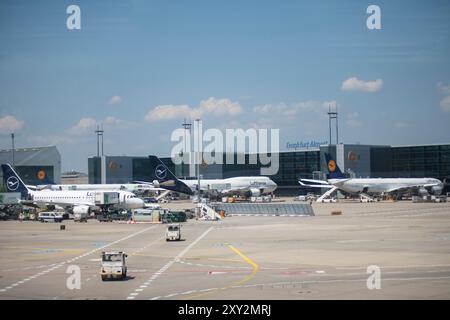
[253,100,337,117]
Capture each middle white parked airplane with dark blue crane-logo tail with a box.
[143,156,277,197]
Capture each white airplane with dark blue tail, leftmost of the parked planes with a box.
[1,164,144,213]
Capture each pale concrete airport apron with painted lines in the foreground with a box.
[0,201,450,300]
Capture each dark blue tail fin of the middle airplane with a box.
[149,156,193,195]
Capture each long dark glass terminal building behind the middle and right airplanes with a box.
[88,143,450,195]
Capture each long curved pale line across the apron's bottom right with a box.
[150,276,450,300]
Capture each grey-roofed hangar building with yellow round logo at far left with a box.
[0,146,61,185]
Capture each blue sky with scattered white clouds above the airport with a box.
[0,0,450,172]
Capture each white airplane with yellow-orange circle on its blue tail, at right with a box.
[299,153,444,200]
